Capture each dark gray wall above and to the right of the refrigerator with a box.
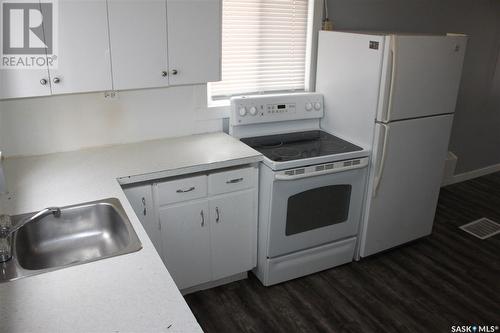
[327,0,500,173]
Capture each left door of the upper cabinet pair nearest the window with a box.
[108,0,168,90]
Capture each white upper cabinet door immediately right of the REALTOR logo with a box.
[42,0,113,94]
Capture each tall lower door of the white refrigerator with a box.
[360,115,453,257]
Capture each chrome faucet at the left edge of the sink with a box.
[0,207,61,263]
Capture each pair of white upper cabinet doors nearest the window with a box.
[108,0,222,90]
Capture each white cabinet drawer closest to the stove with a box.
[208,167,257,194]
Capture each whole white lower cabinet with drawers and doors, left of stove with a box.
[124,167,259,289]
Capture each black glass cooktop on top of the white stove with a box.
[240,130,363,162]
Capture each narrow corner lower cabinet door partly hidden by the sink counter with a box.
[123,185,162,253]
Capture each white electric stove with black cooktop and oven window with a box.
[230,93,369,285]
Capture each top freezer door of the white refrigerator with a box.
[377,35,467,122]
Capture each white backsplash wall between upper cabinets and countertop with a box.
[0,85,222,156]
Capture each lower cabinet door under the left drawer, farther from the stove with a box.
[160,200,211,289]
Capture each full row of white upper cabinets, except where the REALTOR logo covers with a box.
[0,0,222,99]
